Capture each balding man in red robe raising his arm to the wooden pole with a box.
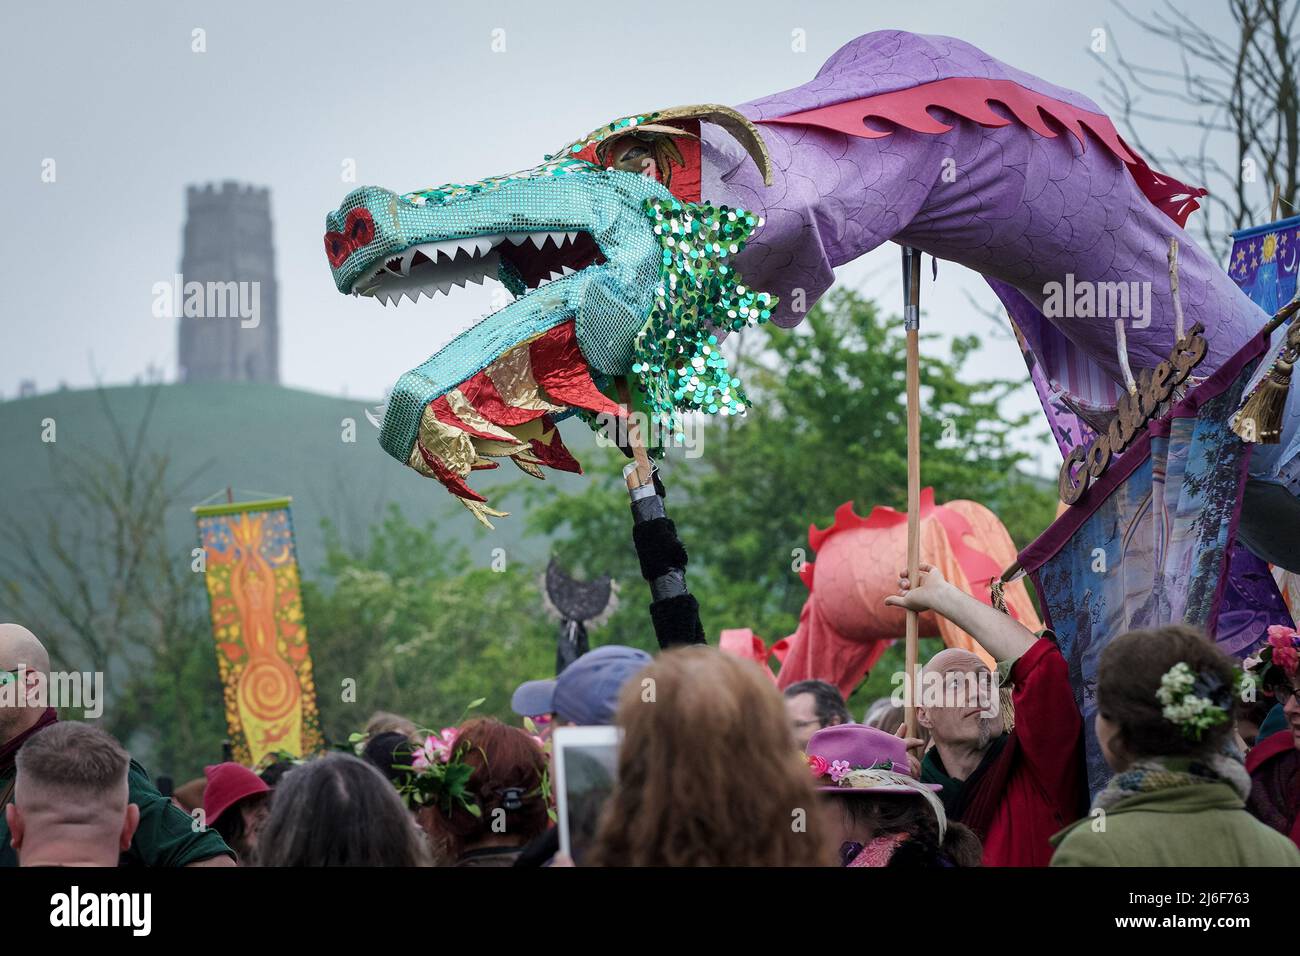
[885,564,1088,866]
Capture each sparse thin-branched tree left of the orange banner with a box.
[0,388,225,777]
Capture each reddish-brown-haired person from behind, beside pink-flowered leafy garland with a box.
[419,718,550,866]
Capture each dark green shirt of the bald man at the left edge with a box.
[0,760,234,866]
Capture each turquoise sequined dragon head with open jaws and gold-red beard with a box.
[325,105,775,527]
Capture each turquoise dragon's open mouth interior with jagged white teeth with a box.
[352,230,605,306]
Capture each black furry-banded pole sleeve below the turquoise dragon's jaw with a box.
[628,466,706,650]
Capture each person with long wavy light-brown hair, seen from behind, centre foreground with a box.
[592,646,833,866]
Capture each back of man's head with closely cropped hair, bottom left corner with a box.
[4,722,140,866]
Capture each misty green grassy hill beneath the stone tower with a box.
[0,384,594,576]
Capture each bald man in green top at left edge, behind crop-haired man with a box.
[0,624,234,866]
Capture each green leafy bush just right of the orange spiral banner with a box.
[303,506,572,741]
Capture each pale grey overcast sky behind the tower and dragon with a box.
[0,0,1262,471]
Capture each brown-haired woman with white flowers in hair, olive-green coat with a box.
[1052,624,1300,866]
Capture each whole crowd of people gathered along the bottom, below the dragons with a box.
[0,566,1300,868]
